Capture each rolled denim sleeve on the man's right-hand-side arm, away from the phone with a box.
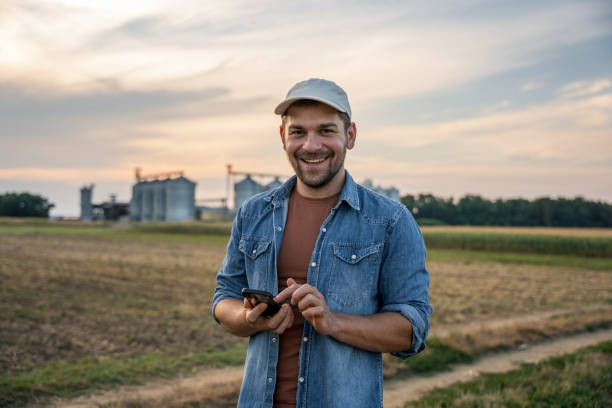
[379,208,433,359]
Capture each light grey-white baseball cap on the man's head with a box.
[274,78,351,118]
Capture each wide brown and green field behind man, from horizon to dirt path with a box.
[0,219,612,406]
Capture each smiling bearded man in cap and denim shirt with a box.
[213,79,432,408]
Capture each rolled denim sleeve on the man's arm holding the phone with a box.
[211,210,249,323]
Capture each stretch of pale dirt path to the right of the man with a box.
[384,329,612,408]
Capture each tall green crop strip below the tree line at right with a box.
[423,231,612,258]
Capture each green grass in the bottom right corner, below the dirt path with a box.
[405,342,612,408]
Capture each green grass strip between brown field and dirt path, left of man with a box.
[0,344,246,407]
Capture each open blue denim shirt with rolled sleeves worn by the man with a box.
[212,172,432,408]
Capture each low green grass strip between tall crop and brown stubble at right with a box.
[427,248,612,271]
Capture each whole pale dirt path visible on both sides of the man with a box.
[53,329,612,408]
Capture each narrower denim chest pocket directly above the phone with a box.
[238,238,271,290]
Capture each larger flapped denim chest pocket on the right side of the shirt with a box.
[328,243,382,313]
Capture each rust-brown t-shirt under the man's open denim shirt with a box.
[274,189,340,408]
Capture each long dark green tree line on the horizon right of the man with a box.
[402,194,612,227]
